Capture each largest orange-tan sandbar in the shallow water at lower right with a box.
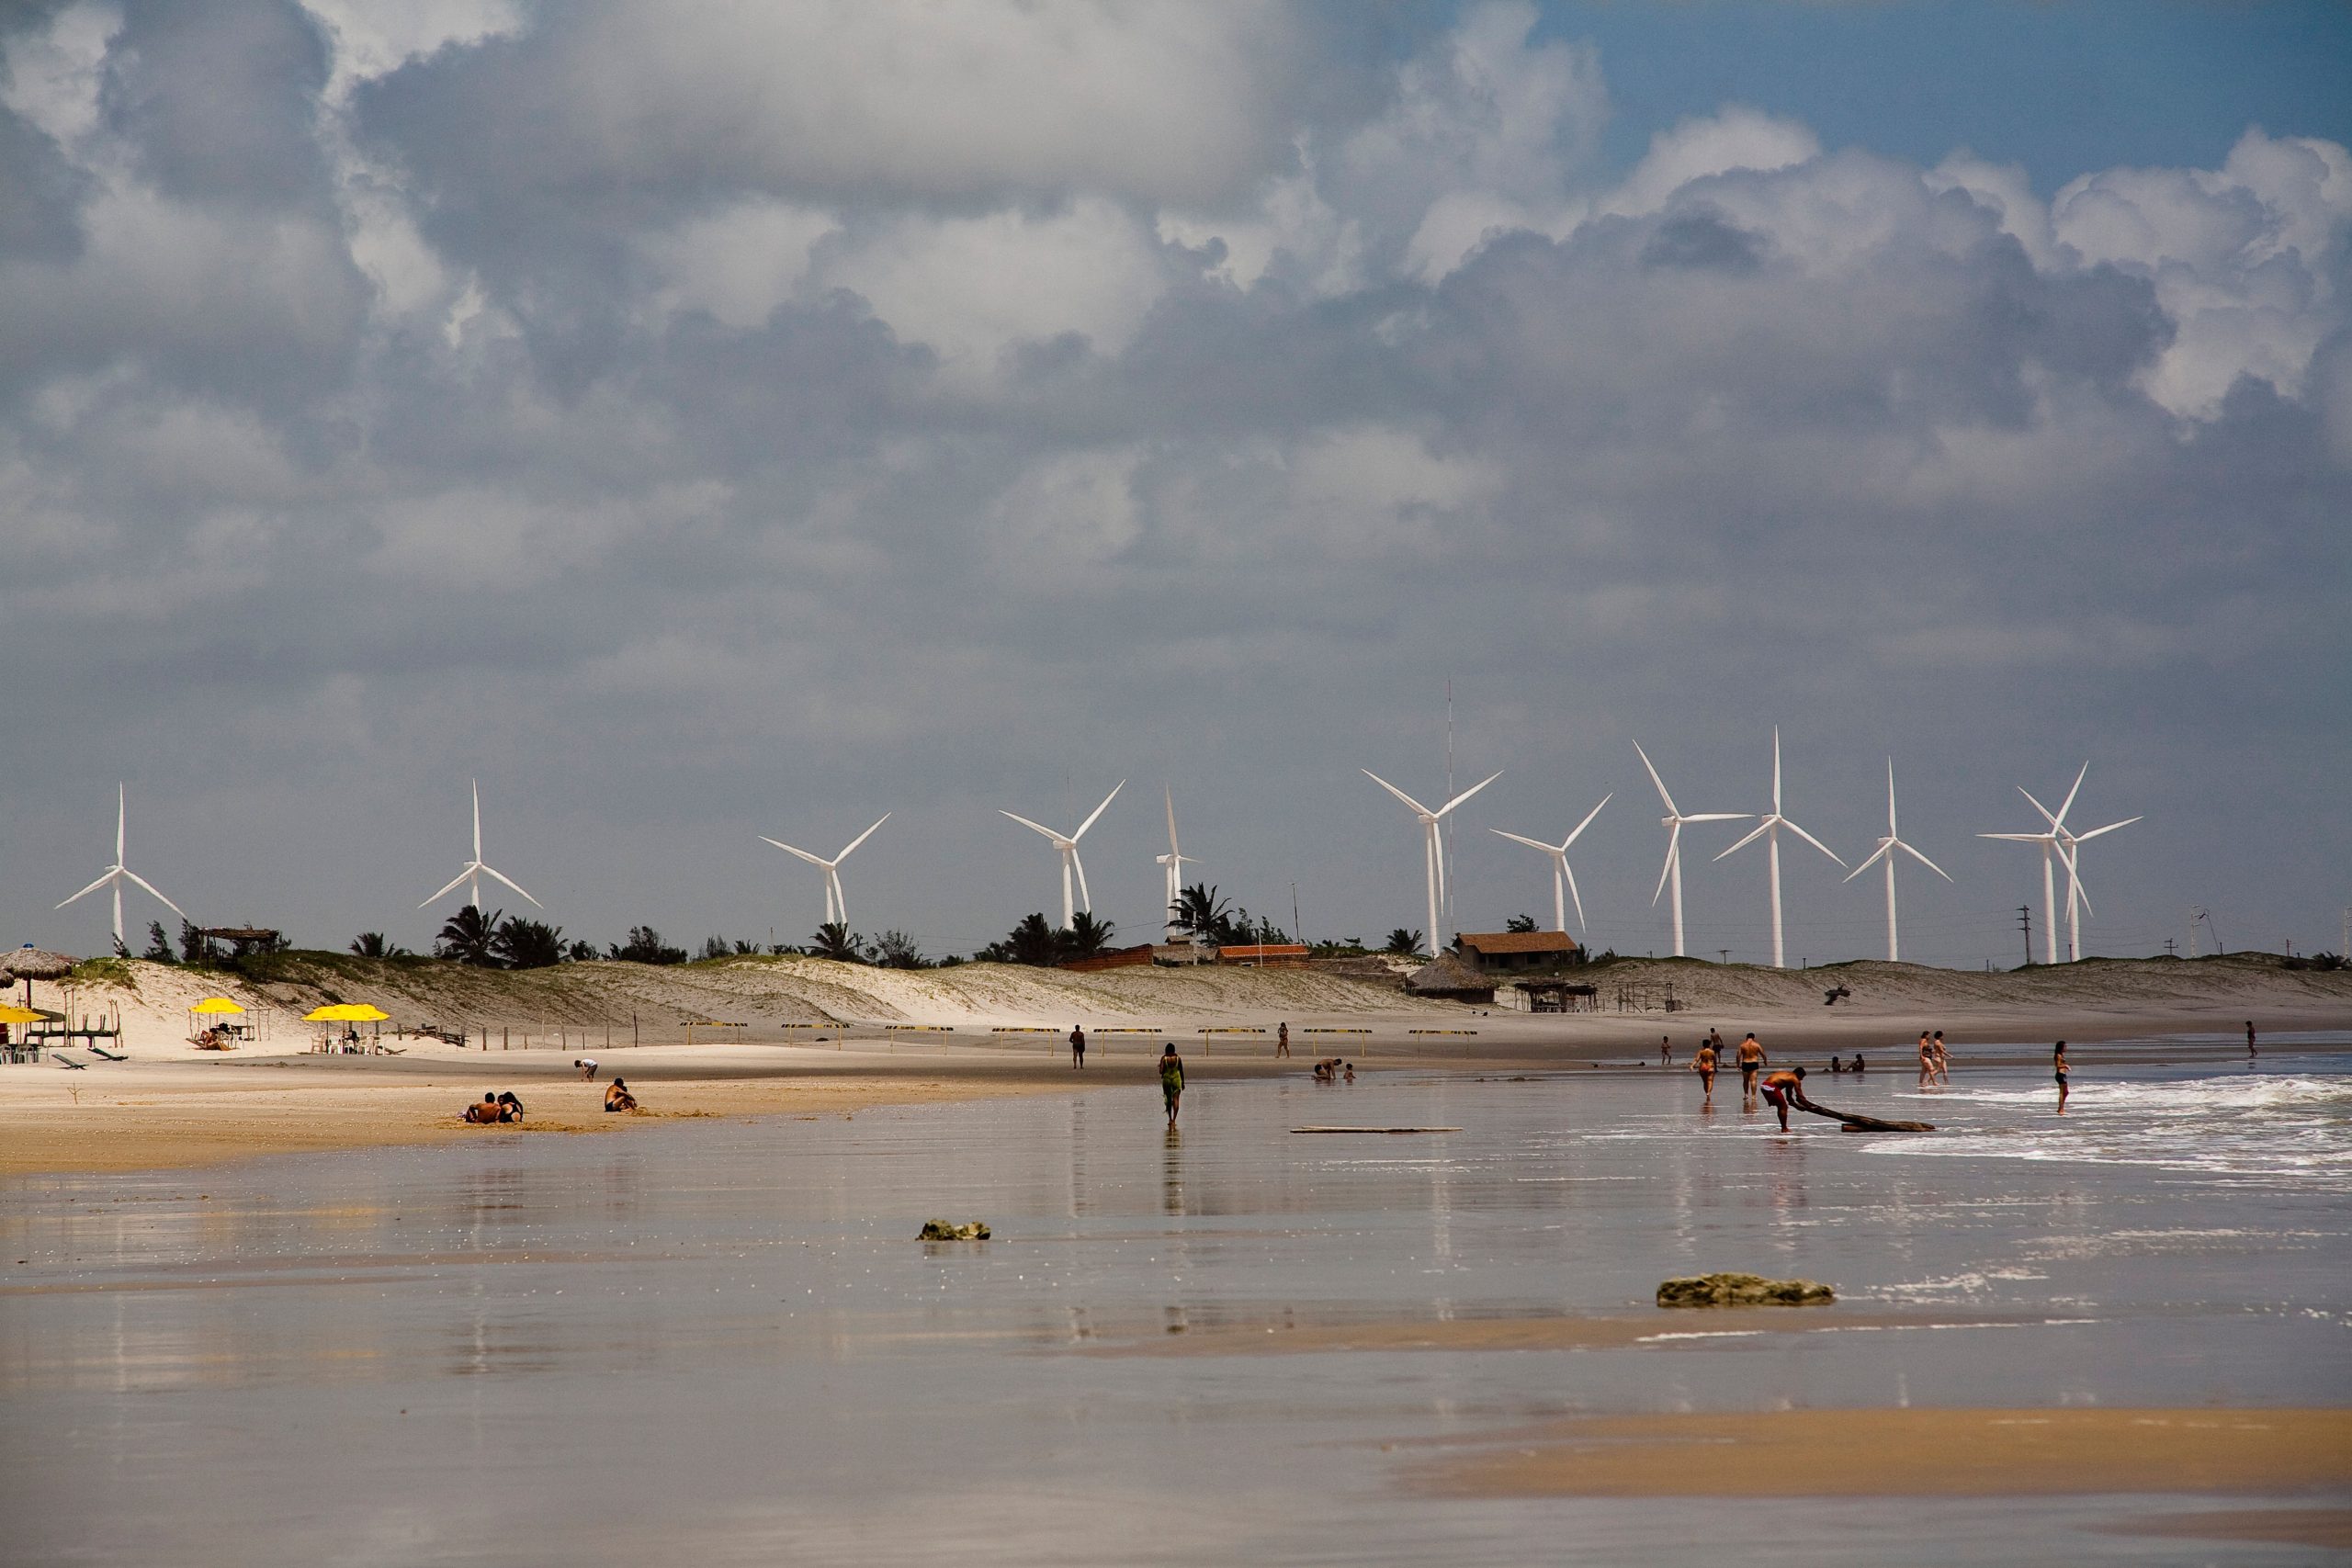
[1419,1408,2352,1497]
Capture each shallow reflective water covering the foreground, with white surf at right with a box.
[0,1048,2352,1563]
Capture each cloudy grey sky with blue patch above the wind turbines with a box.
[0,0,2352,966]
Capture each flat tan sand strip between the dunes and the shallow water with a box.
[0,1018,2352,1180]
